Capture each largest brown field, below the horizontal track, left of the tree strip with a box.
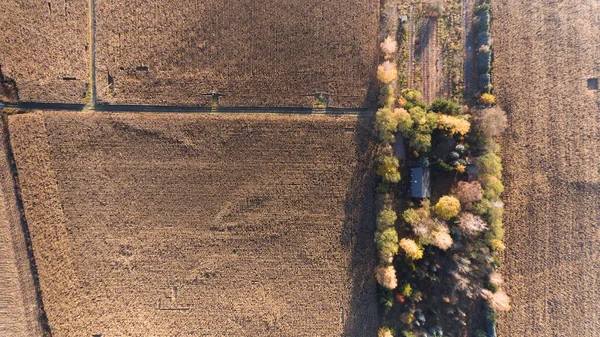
[9,112,377,337]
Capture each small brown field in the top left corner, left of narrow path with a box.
[0,0,89,103]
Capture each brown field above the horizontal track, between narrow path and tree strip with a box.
[96,0,379,108]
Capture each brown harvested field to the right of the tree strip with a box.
[492,0,600,337]
